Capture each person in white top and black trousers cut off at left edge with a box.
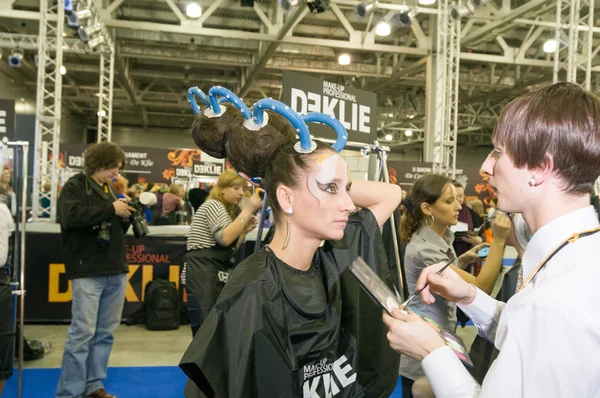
[0,187,15,396]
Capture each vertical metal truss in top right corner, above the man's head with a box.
[552,0,600,90]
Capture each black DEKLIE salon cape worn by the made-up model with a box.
[179,209,399,398]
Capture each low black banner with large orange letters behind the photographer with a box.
[25,232,186,322]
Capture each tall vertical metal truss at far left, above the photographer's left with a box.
[32,0,65,221]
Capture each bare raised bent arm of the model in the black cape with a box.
[350,181,402,228]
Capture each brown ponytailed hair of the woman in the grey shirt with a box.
[400,174,452,242]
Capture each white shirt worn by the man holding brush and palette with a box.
[421,206,600,398]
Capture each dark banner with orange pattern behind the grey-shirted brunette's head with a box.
[388,161,493,207]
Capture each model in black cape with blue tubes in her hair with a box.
[180,87,401,397]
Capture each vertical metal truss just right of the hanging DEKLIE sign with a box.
[433,0,460,178]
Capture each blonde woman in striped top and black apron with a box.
[186,170,262,334]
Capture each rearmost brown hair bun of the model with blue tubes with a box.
[192,104,244,159]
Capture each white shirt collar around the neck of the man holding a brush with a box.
[522,206,598,277]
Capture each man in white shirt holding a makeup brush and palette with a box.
[384,83,600,398]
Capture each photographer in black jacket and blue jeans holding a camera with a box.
[56,142,135,398]
